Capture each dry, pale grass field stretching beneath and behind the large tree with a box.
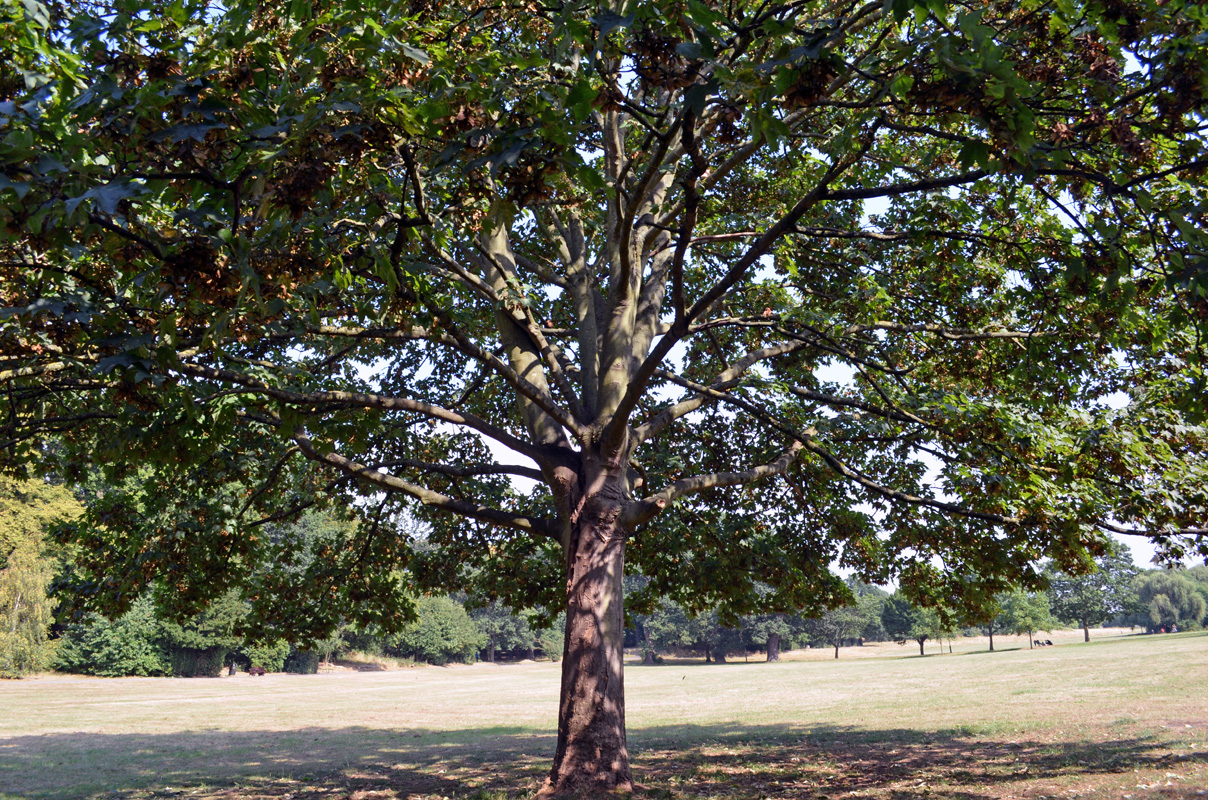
[0,632,1208,800]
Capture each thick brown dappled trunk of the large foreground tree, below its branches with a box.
[538,475,633,798]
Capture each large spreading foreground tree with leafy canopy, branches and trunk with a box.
[0,0,1208,793]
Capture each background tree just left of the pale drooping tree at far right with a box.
[1049,551,1137,642]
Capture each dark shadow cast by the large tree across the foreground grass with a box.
[0,724,1208,800]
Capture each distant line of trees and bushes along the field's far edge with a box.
[0,479,1208,677]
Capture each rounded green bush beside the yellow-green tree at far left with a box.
[54,598,169,678]
